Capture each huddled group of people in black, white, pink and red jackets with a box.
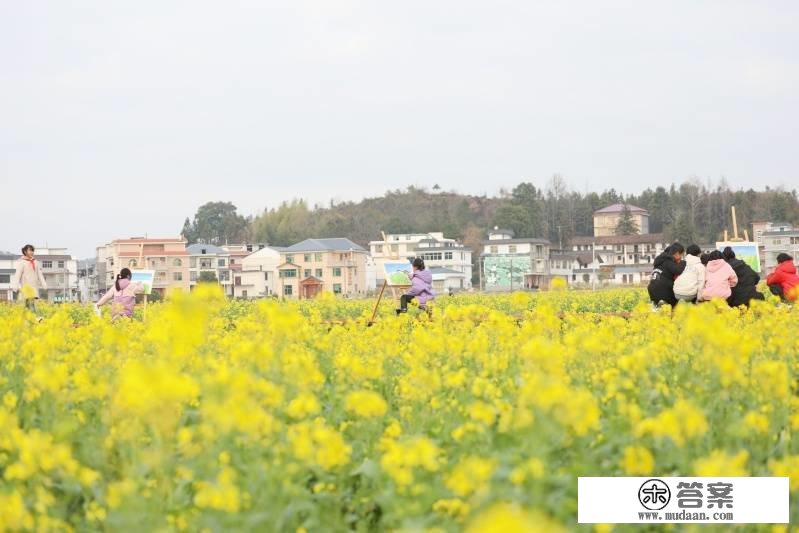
[647,242,799,307]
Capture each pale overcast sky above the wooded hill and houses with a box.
[0,0,799,257]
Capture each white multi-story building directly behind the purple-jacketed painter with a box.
[369,232,472,290]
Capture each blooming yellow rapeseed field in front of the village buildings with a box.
[0,287,799,532]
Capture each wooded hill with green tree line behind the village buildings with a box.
[181,175,799,255]
